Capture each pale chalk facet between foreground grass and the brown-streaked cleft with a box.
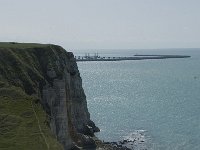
[43,79,73,149]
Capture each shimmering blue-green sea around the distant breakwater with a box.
[74,48,200,150]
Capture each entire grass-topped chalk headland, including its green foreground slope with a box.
[0,43,99,150]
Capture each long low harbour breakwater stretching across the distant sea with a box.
[75,55,191,61]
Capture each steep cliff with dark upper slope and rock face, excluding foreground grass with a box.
[0,43,99,150]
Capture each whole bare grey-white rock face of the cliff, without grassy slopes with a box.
[42,52,98,150]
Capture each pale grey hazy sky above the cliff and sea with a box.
[0,0,200,49]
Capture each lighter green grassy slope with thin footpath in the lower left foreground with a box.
[0,87,62,150]
